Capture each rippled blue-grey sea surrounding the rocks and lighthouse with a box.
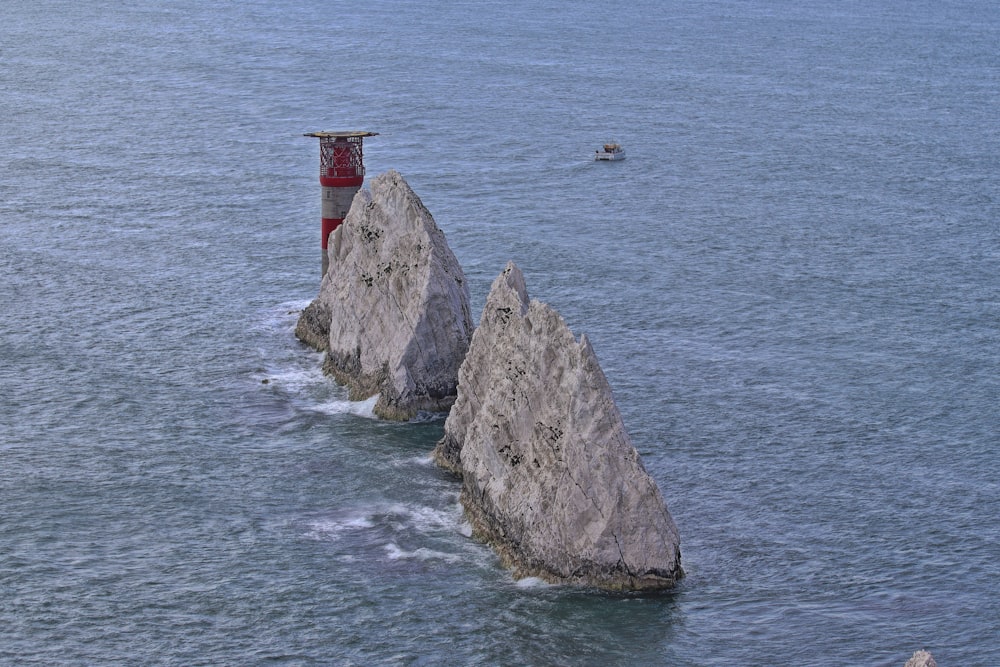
[0,0,1000,667]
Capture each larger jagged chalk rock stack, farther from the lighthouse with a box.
[434,263,683,589]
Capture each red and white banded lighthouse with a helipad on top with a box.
[303,132,378,276]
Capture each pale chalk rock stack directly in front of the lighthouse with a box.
[296,170,474,420]
